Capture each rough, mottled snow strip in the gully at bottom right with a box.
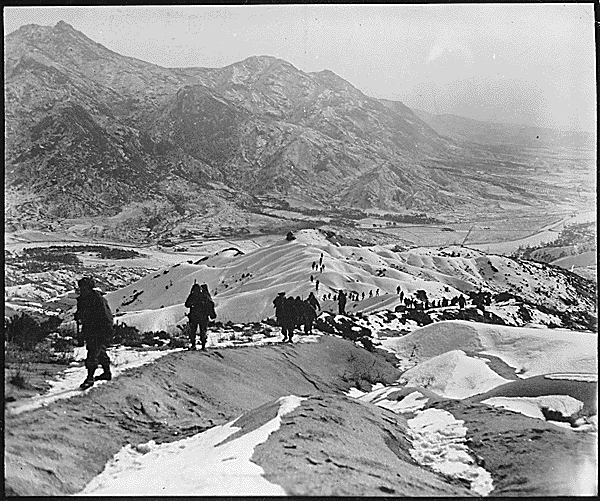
[408,409,494,496]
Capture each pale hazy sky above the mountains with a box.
[4,3,596,130]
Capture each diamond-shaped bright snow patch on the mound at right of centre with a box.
[401,350,508,399]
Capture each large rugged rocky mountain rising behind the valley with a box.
[5,21,564,239]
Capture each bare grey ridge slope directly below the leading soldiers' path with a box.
[4,336,399,495]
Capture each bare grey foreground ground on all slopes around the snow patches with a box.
[5,336,596,497]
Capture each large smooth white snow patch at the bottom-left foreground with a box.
[79,395,305,496]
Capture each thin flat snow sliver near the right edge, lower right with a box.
[482,395,583,420]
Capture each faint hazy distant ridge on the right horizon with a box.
[413,109,595,149]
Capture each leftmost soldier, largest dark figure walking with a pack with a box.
[75,277,113,390]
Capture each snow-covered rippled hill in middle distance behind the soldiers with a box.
[107,230,595,330]
